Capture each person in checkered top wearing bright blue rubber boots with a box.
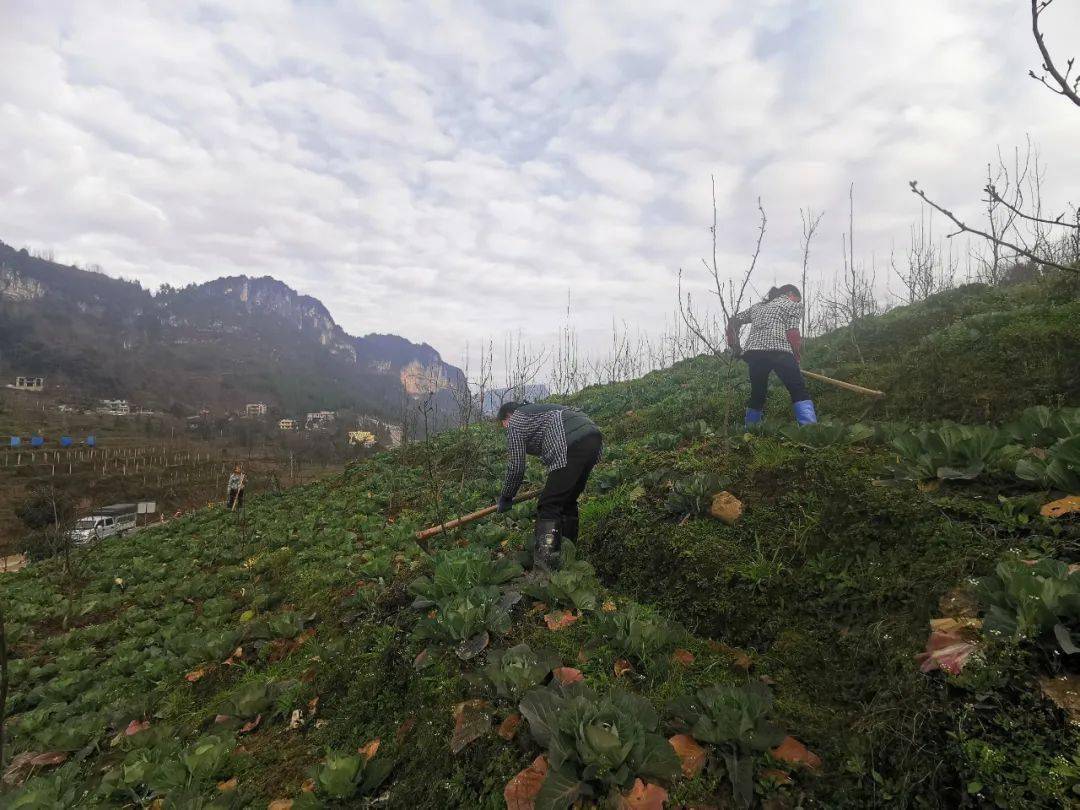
[727,284,818,427]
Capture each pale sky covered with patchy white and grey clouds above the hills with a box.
[0,0,1080,371]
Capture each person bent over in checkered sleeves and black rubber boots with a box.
[498,402,603,571]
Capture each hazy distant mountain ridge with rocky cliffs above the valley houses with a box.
[0,242,462,421]
